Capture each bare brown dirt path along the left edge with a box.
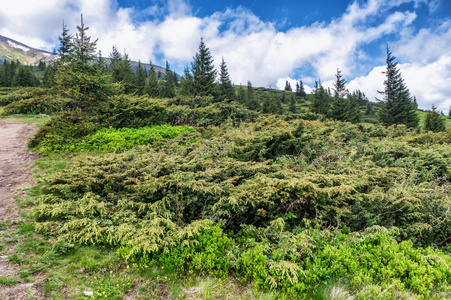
[0,119,38,299]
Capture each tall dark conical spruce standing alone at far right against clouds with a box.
[379,45,418,128]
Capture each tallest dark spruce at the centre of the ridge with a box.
[191,38,216,96]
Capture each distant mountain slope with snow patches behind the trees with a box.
[0,35,165,74]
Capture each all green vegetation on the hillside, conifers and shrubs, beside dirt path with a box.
[0,14,451,299]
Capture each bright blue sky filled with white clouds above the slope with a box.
[0,0,451,113]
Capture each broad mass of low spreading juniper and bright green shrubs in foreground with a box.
[24,117,451,299]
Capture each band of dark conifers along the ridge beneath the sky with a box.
[0,15,451,132]
